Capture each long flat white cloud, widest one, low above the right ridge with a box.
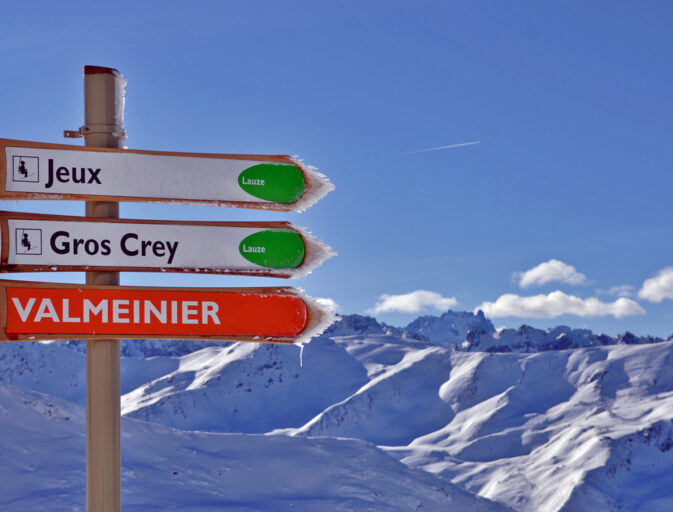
[475,290,645,318]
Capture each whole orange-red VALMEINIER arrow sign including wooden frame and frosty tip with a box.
[0,281,332,343]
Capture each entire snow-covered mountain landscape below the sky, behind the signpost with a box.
[0,311,673,512]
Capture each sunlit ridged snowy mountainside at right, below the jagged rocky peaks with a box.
[390,342,673,511]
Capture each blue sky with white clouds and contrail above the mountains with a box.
[0,0,673,336]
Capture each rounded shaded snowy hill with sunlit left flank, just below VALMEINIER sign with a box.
[122,340,367,433]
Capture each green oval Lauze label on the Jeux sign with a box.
[238,164,306,204]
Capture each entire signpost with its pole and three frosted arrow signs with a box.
[0,66,333,512]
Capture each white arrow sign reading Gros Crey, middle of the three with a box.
[0,212,334,277]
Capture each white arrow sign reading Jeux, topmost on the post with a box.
[0,139,334,211]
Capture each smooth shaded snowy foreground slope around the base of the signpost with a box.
[0,385,504,512]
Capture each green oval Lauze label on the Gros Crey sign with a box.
[238,230,306,268]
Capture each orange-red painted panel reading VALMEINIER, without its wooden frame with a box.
[6,287,308,337]
